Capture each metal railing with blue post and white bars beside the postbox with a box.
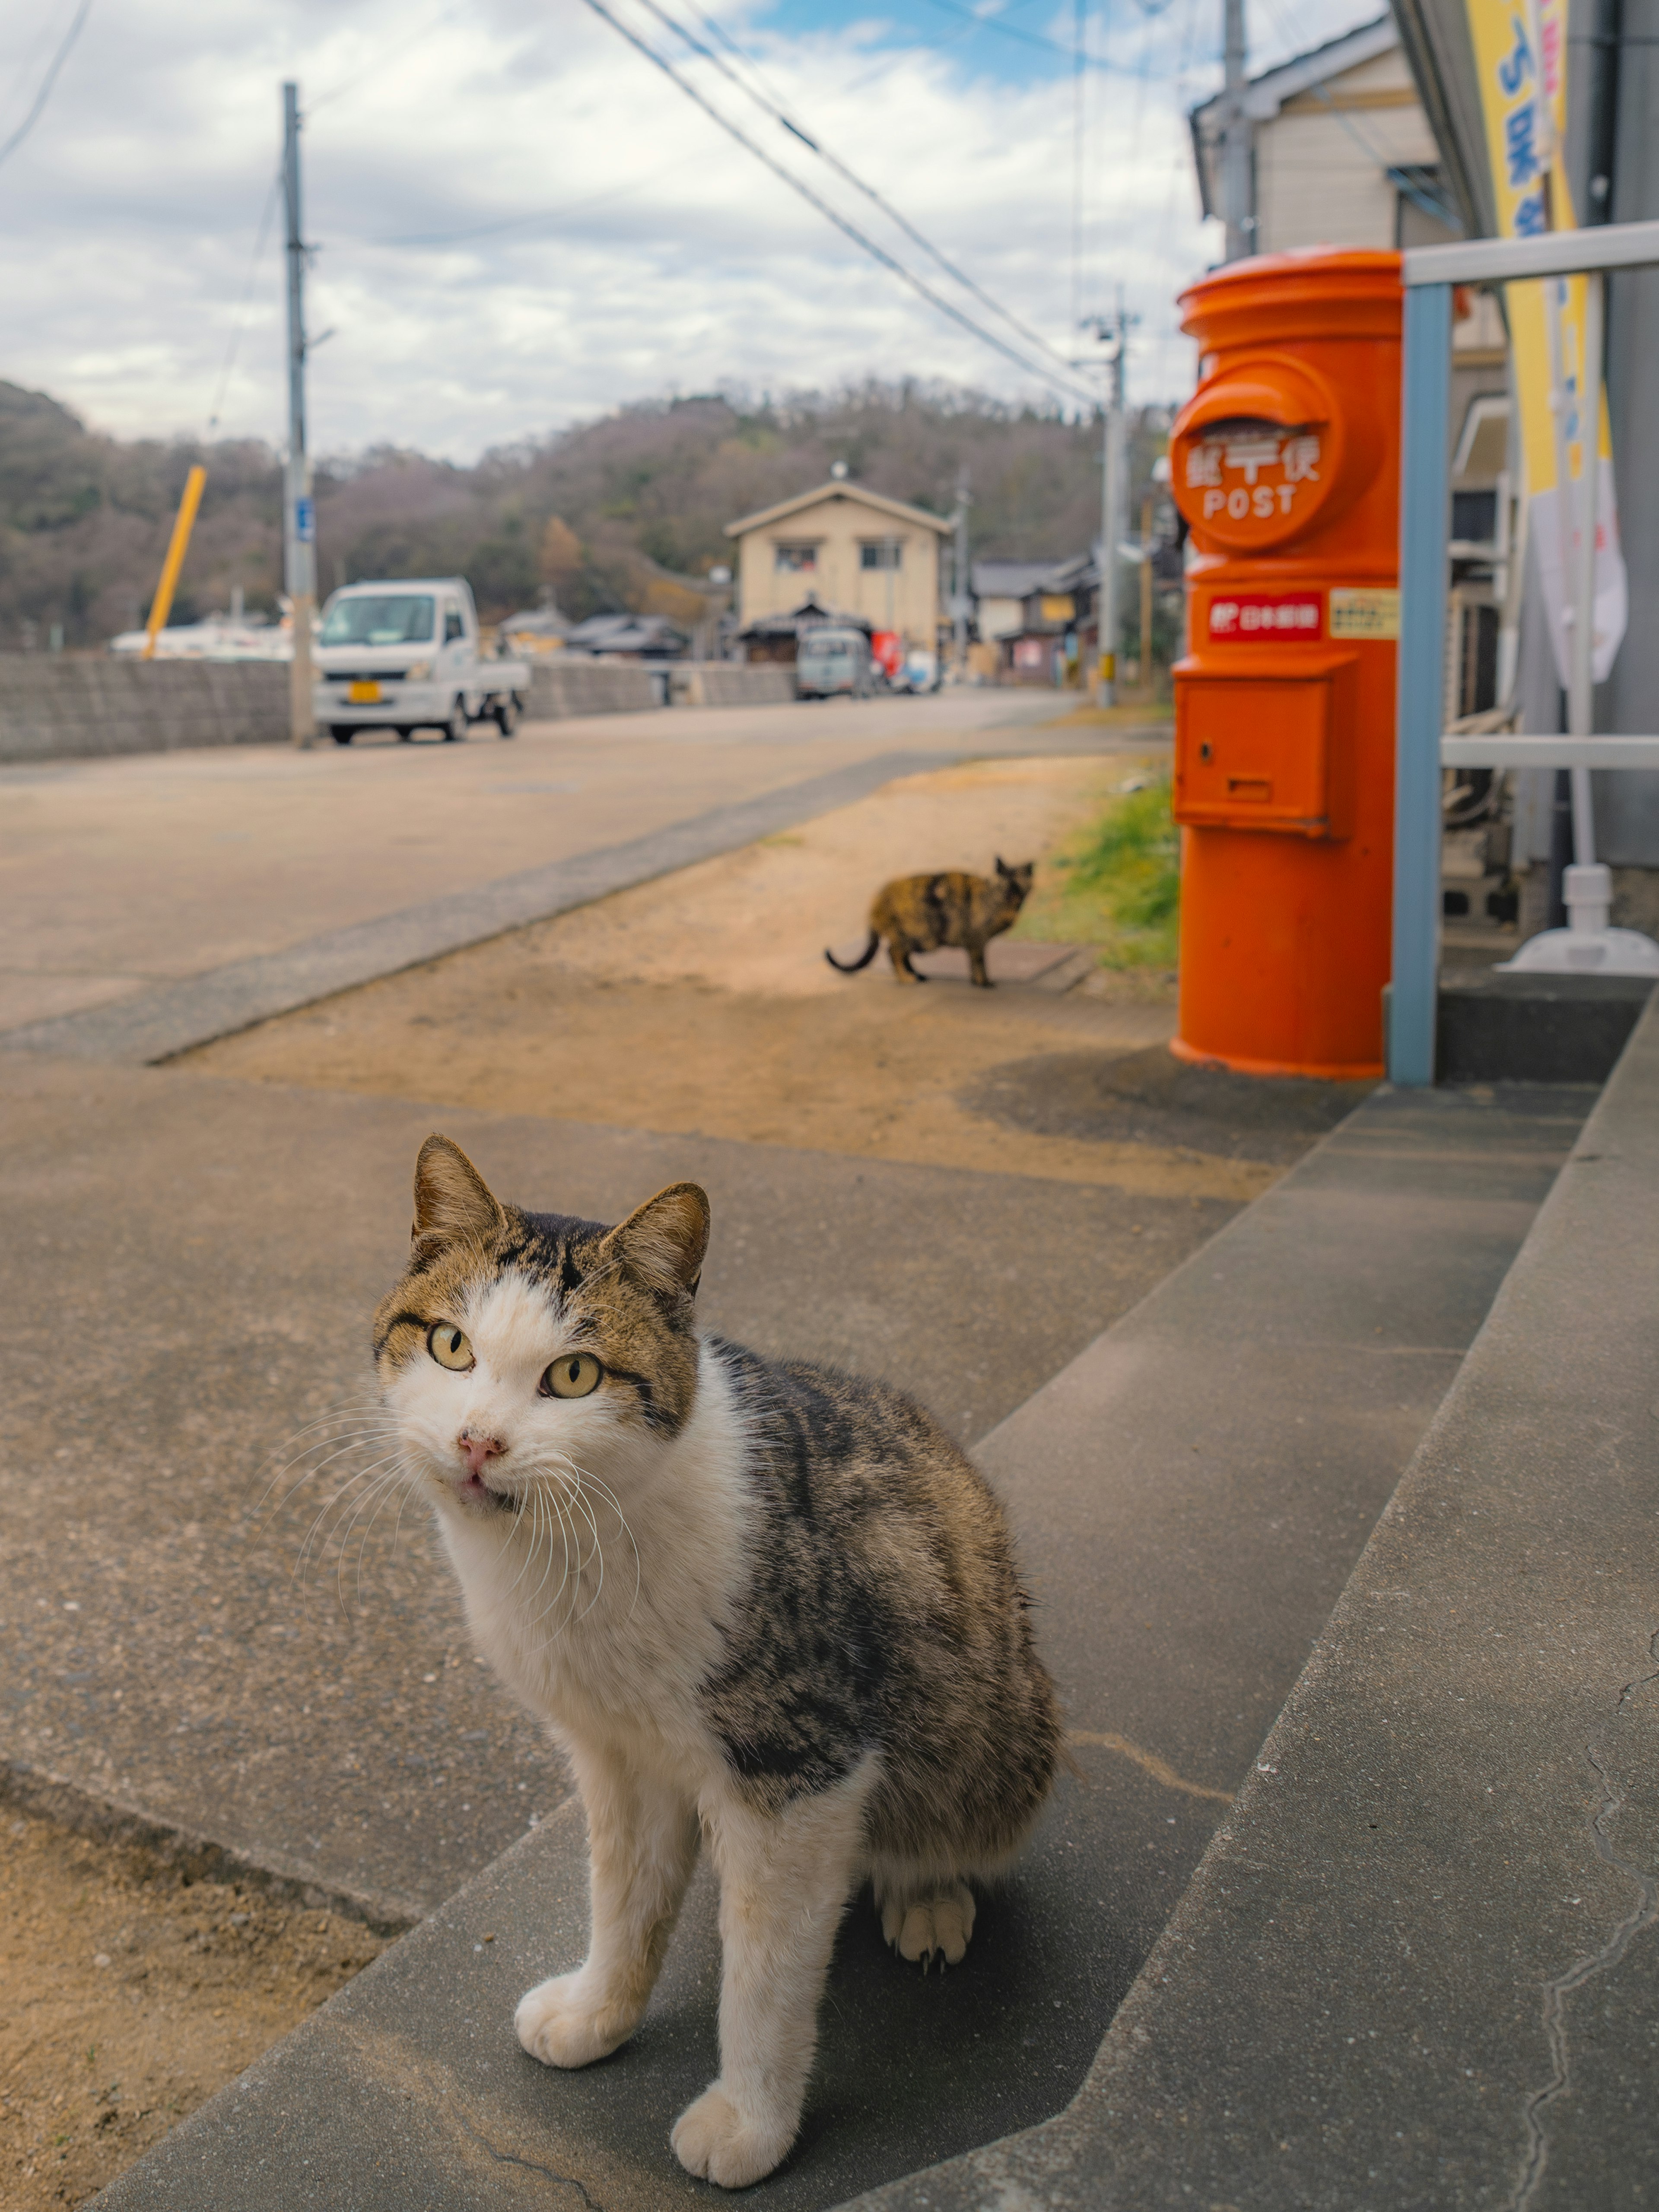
[1387,223,1659,1086]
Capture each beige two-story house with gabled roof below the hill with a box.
[725,478,951,650]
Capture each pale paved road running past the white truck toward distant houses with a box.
[0,690,1079,1033]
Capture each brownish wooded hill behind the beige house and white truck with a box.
[0,383,1153,650]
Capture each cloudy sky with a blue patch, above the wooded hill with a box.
[0,0,1376,460]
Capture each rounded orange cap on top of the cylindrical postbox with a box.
[1179,245,1405,352]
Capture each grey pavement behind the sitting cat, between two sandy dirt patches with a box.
[0,1053,1232,1920]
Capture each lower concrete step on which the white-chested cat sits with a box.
[88,1093,1588,2212]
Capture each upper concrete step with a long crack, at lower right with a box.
[867,1009,1659,2212]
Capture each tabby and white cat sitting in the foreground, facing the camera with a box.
[374,1137,1059,2188]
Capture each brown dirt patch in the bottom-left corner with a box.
[0,1814,387,2212]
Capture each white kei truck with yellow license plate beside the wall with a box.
[312,575,531,745]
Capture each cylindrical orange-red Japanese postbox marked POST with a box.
[1170,250,1400,1077]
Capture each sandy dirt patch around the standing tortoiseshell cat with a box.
[192,754,1300,1201]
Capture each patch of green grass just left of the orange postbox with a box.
[1017,776,1181,969]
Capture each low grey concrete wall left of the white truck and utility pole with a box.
[0,652,288,761]
